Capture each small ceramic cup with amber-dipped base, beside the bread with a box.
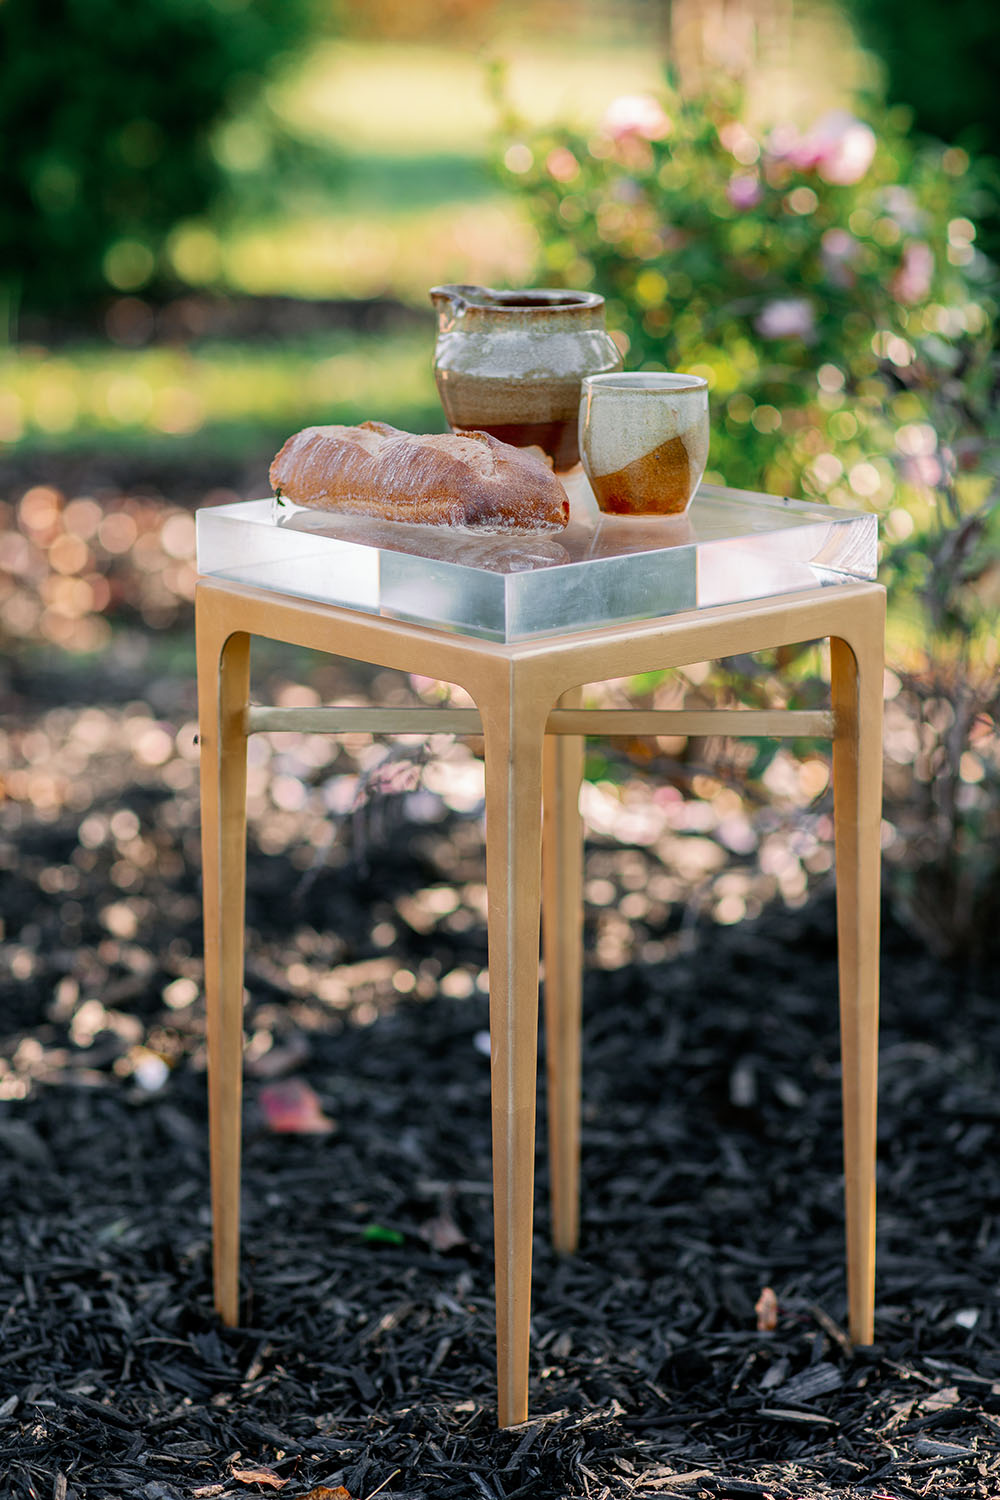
[580,371,708,516]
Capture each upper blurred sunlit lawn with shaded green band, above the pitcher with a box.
[168,42,661,303]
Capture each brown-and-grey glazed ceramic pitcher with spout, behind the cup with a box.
[430,285,622,471]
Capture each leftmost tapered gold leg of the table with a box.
[198,591,250,1325]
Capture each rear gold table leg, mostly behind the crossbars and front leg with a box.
[541,689,583,1254]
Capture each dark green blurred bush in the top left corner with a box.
[0,0,313,309]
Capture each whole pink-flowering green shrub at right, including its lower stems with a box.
[501,81,1000,951]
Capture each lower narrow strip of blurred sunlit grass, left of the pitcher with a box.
[0,320,444,444]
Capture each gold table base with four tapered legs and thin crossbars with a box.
[196,579,885,1427]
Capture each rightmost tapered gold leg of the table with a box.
[831,593,885,1344]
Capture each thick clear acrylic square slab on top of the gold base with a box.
[198,473,877,641]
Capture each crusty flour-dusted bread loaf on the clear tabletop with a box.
[270,422,570,531]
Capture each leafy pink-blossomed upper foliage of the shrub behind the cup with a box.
[504,87,994,509]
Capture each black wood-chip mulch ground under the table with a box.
[0,651,1000,1500]
